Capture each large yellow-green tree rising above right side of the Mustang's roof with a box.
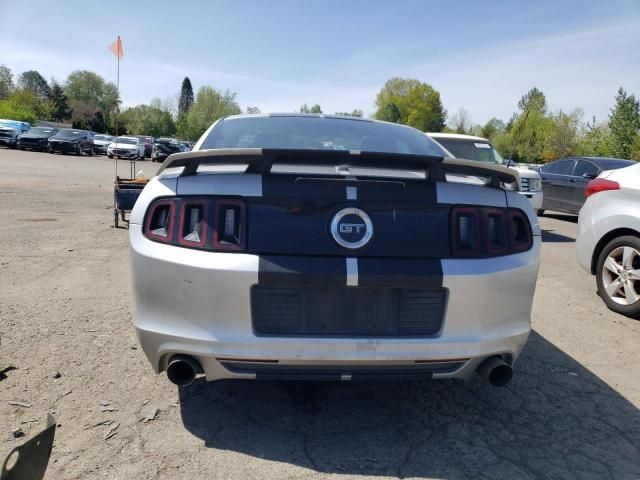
[374,77,446,132]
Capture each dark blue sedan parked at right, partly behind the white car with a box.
[538,157,636,215]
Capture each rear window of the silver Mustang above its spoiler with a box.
[200,116,445,157]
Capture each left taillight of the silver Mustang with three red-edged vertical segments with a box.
[143,197,246,251]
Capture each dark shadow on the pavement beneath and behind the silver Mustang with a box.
[179,332,640,480]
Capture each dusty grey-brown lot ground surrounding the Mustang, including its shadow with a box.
[0,149,640,479]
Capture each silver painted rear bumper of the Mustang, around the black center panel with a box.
[129,224,540,380]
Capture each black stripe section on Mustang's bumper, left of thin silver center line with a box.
[258,255,347,287]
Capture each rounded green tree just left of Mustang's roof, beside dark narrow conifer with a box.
[178,86,242,140]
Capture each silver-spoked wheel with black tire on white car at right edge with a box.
[596,236,640,318]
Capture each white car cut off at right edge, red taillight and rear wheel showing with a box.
[576,163,640,318]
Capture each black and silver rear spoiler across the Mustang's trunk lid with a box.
[157,148,520,190]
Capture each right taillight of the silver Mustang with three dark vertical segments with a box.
[451,206,533,258]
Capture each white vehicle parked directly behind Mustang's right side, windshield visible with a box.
[427,133,542,210]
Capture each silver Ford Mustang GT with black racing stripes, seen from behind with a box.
[129,114,540,385]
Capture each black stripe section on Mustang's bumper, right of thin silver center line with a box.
[358,258,443,289]
